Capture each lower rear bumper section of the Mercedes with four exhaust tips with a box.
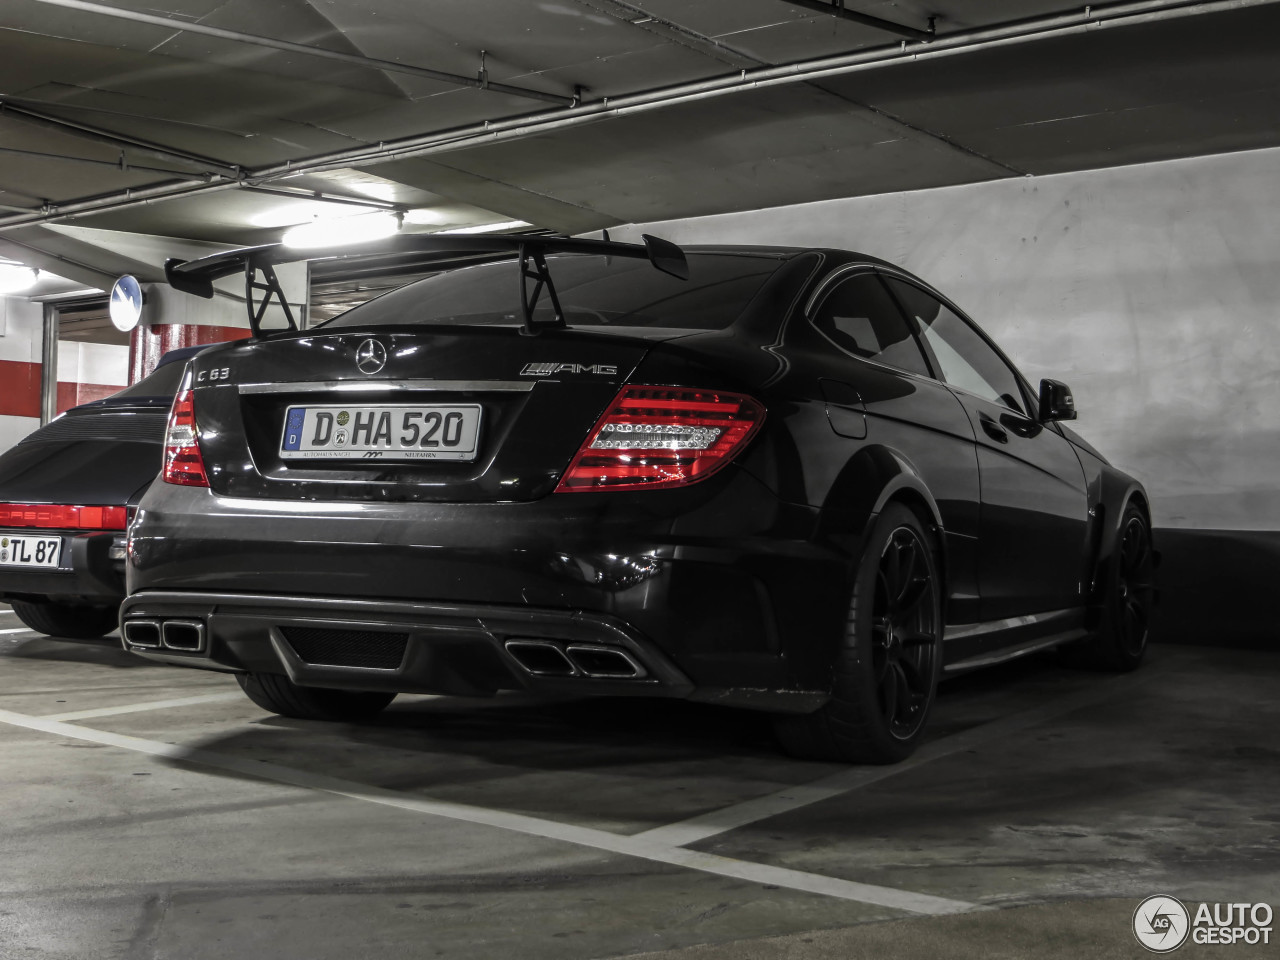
[120,591,694,698]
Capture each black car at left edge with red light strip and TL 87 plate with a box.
[0,347,205,639]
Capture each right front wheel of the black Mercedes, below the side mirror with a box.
[1062,500,1156,672]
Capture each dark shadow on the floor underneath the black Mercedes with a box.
[147,658,1111,809]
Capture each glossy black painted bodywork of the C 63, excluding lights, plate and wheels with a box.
[122,250,1144,709]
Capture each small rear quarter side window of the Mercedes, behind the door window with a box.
[813,273,931,376]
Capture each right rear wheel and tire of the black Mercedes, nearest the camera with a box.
[776,503,942,763]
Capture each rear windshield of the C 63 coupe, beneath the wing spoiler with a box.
[324,253,782,330]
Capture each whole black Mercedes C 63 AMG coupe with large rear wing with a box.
[122,237,1155,762]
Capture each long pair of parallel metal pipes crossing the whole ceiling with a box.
[0,0,1280,233]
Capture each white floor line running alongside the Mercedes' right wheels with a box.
[634,673,1147,846]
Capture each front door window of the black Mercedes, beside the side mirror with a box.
[884,276,1027,415]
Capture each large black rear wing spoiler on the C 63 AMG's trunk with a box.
[164,234,689,337]
